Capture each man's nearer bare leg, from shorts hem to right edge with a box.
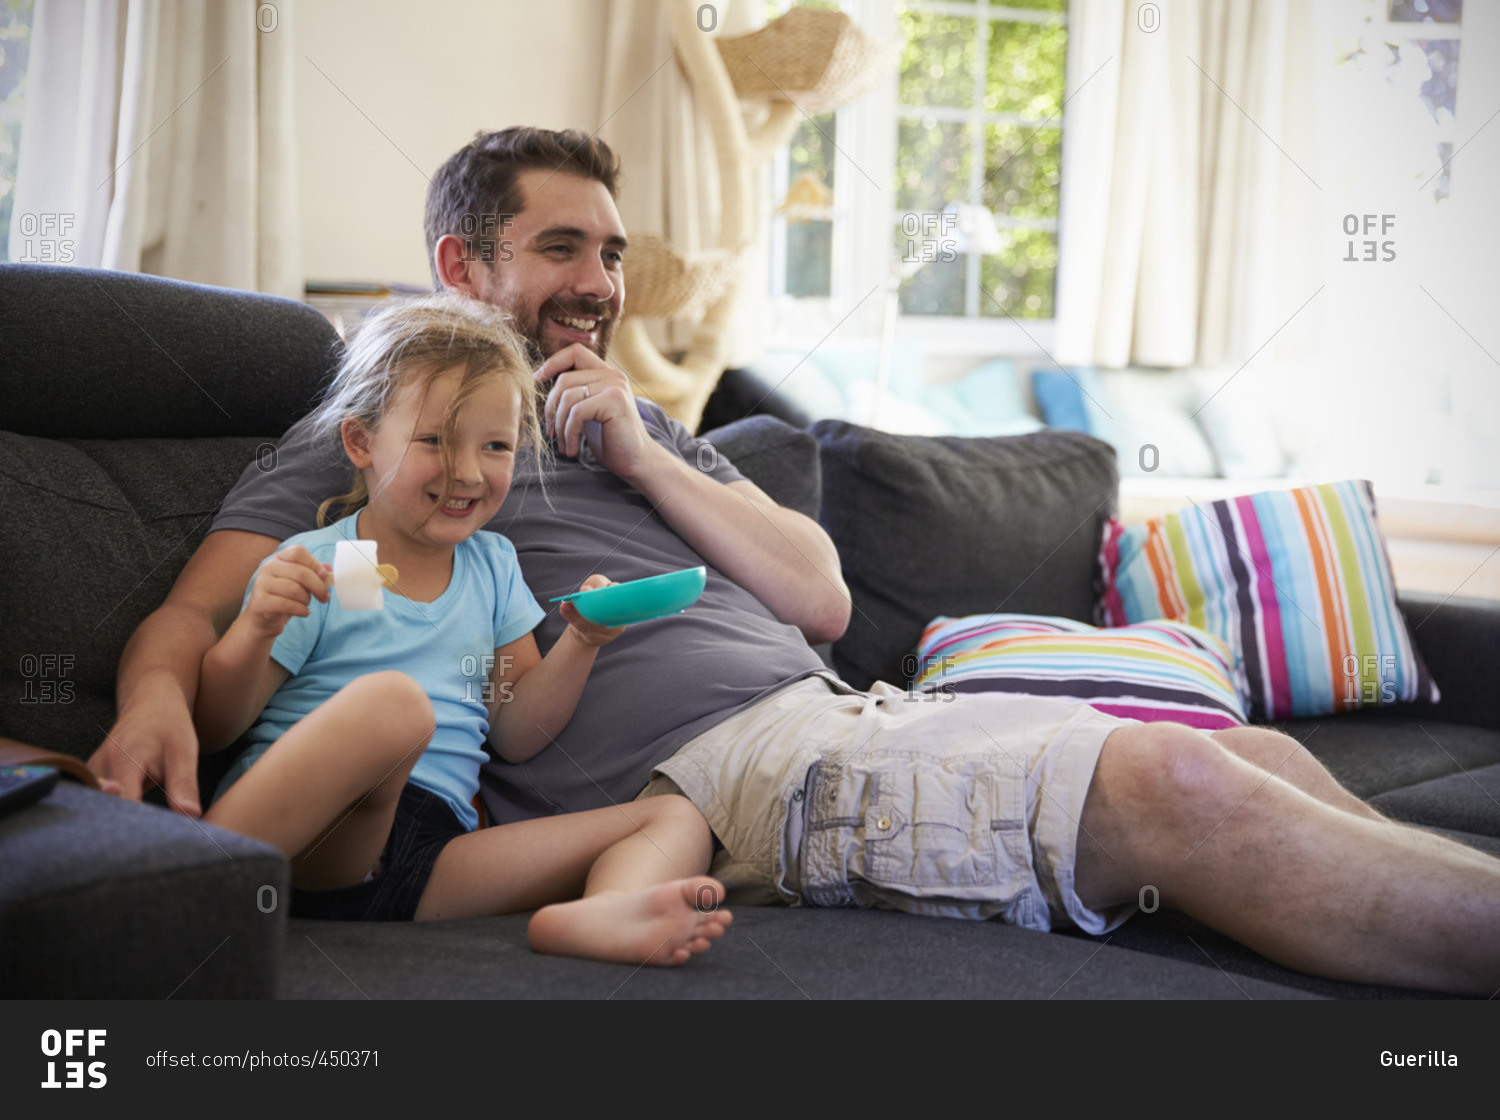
[1076,724,1500,996]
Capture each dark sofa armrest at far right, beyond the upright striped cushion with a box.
[1398,591,1500,730]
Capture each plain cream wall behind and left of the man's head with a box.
[291,0,606,285]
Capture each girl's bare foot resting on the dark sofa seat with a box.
[527,876,734,964]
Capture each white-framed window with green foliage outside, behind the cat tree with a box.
[767,0,1067,354]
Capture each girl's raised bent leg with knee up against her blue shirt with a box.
[204,672,434,889]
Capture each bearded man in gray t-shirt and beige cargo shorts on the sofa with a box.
[90,129,1500,994]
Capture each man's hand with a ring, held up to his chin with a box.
[534,342,660,484]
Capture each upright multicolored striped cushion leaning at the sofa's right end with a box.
[1100,480,1439,721]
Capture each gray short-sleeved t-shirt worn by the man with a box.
[210,400,824,822]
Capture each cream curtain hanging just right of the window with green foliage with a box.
[1056,0,1322,367]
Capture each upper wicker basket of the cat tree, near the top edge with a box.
[714,7,902,115]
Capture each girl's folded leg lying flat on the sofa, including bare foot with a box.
[417,796,731,964]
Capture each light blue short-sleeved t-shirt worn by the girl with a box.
[215,513,545,829]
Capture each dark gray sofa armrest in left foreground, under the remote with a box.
[0,781,290,999]
